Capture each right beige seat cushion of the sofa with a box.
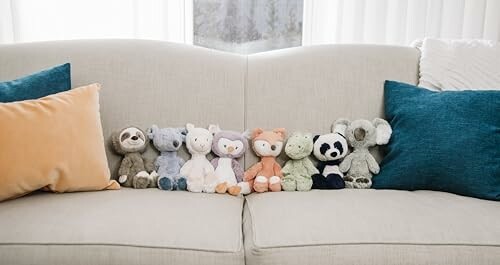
[243,189,500,265]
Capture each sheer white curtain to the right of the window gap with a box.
[302,0,500,45]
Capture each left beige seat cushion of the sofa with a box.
[0,188,244,265]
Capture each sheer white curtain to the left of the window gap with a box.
[0,0,193,43]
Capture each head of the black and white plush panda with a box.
[313,133,349,161]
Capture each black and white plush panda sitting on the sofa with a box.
[312,120,349,189]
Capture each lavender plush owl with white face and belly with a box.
[212,131,250,196]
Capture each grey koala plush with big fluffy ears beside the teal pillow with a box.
[340,118,392,189]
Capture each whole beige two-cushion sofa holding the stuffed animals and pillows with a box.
[0,40,500,265]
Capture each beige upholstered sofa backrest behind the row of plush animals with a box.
[0,40,419,176]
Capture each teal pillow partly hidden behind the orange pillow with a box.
[0,63,71,102]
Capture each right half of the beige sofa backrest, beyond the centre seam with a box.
[245,45,419,167]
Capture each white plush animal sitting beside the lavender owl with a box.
[180,123,220,193]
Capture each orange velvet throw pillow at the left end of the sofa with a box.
[0,84,120,201]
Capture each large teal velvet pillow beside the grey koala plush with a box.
[373,81,500,200]
